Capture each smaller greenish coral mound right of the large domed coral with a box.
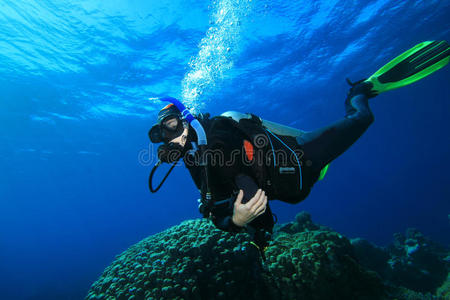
[265,212,383,299]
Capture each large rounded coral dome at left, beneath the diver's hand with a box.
[87,220,264,299]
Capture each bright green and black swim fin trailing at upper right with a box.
[366,41,450,94]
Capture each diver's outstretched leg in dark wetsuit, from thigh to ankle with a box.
[297,90,374,172]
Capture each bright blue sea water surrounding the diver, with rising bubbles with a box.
[0,0,450,299]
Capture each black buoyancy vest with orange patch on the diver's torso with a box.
[215,114,319,203]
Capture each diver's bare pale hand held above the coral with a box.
[232,189,267,227]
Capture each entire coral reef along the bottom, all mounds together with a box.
[86,212,450,300]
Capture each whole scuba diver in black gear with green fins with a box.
[149,41,450,260]
